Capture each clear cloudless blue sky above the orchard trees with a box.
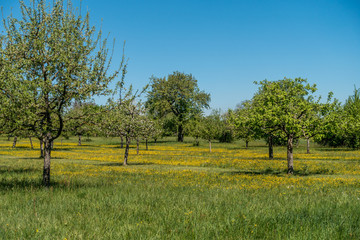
[0,0,360,110]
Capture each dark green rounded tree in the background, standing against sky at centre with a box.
[146,72,210,142]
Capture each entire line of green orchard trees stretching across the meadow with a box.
[0,0,360,186]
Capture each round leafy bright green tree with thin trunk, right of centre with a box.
[253,78,317,174]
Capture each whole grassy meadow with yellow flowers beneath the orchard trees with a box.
[0,137,360,240]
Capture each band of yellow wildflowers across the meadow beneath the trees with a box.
[0,143,360,189]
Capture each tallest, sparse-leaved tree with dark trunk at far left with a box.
[0,0,121,186]
